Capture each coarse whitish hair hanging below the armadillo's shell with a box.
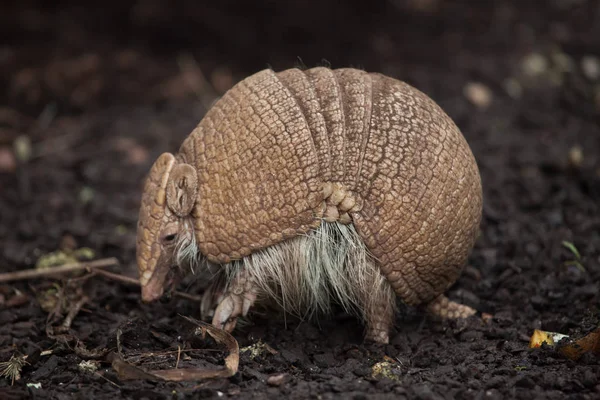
[175,221,396,323]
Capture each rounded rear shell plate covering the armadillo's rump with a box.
[353,74,482,304]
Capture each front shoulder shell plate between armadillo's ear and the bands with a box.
[182,70,322,262]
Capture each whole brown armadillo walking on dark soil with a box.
[137,67,482,343]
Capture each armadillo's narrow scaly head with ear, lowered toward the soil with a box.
[137,153,198,302]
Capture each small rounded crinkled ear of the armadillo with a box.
[167,164,198,217]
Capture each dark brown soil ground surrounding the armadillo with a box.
[0,0,600,399]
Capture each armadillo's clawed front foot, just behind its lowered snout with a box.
[212,271,257,332]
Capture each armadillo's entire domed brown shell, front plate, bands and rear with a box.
[180,68,481,303]
